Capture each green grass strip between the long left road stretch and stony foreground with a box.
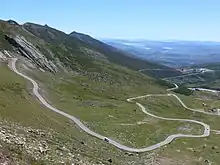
[0,62,143,164]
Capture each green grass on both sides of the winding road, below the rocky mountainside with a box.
[0,60,220,164]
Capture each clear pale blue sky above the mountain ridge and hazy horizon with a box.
[0,0,220,41]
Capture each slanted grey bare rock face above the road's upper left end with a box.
[5,35,58,73]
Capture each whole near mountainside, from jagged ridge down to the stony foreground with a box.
[0,20,220,165]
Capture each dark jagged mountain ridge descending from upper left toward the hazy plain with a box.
[0,20,170,75]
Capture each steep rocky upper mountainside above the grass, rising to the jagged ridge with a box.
[0,21,170,72]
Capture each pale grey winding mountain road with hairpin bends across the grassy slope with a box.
[8,58,213,153]
